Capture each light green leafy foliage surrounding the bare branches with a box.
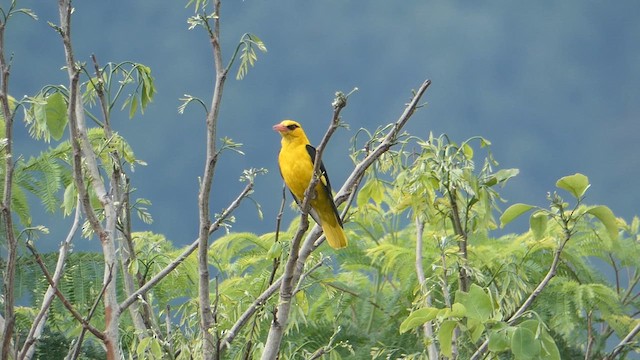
[0,0,640,359]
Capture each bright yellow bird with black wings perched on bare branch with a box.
[273,120,347,249]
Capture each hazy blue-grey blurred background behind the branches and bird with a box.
[2,0,640,249]
